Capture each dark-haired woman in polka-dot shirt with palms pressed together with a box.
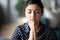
[12,0,57,40]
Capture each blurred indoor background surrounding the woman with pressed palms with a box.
[0,0,60,40]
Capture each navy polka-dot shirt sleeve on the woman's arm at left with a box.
[11,26,22,40]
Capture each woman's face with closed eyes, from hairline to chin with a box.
[25,4,42,23]
